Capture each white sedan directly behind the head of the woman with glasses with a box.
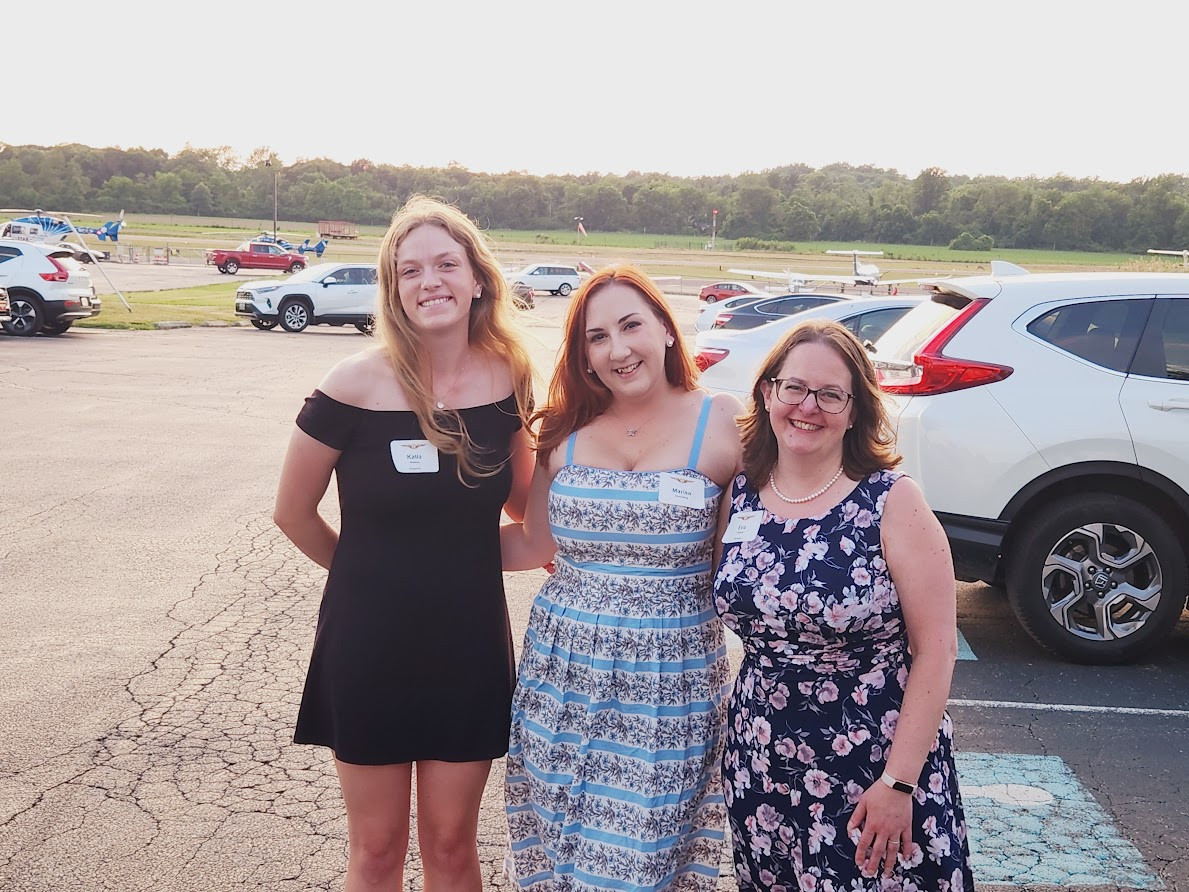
[694,295,924,402]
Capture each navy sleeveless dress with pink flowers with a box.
[715,471,974,892]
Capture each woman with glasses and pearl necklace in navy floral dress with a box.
[715,320,974,892]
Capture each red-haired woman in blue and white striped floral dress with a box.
[503,268,742,892]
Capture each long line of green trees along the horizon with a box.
[0,143,1189,251]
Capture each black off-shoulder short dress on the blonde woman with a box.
[294,390,521,765]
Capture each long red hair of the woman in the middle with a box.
[533,265,698,457]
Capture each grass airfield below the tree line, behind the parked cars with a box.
[67,214,1181,328]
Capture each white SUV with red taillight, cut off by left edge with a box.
[0,239,102,338]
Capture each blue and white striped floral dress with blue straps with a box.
[507,397,729,892]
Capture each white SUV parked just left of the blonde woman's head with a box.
[235,263,377,334]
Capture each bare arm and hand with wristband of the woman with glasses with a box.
[848,477,958,875]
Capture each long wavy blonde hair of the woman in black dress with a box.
[376,195,533,483]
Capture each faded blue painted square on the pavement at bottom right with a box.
[956,752,1165,890]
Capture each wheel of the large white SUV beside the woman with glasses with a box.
[1007,494,1189,664]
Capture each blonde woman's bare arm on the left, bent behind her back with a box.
[272,428,341,570]
